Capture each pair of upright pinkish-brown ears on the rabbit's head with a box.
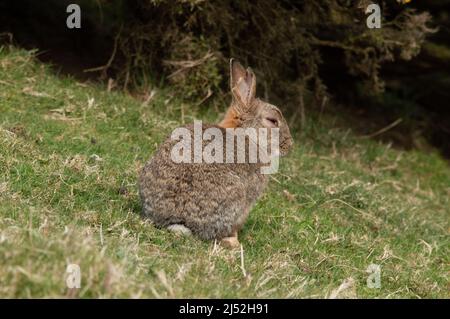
[230,59,256,112]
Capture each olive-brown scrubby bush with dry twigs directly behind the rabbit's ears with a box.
[105,0,433,101]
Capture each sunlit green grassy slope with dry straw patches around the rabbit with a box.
[0,47,450,298]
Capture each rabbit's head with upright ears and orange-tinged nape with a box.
[220,59,293,155]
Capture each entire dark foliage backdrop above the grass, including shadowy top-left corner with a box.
[0,0,440,106]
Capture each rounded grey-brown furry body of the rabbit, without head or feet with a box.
[139,126,267,239]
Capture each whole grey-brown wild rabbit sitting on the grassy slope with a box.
[138,59,293,248]
